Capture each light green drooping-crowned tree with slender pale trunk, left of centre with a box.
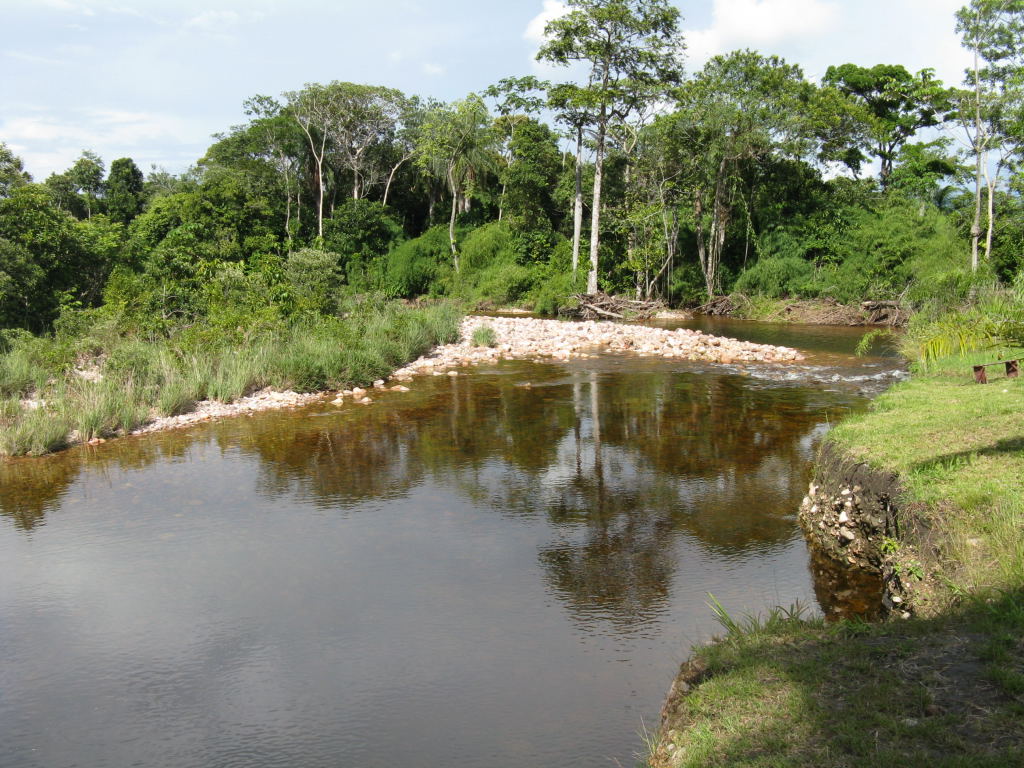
[417,93,494,271]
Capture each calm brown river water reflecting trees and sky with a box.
[0,321,896,768]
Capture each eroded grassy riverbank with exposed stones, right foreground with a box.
[649,355,1024,768]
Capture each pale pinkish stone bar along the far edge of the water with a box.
[132,316,803,434]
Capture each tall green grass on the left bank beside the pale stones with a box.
[0,300,460,456]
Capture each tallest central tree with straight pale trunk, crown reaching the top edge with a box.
[537,0,683,293]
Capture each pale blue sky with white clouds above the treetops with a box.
[0,0,969,181]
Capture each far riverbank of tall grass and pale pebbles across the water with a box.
[0,307,803,455]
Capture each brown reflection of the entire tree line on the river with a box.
[0,364,860,623]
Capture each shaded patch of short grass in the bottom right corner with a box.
[652,593,1024,768]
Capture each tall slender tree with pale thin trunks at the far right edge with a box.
[956,0,1024,270]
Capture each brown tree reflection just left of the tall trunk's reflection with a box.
[227,366,571,508]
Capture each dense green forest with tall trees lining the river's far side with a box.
[0,0,1024,451]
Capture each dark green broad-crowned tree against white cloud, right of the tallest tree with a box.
[824,63,952,187]
